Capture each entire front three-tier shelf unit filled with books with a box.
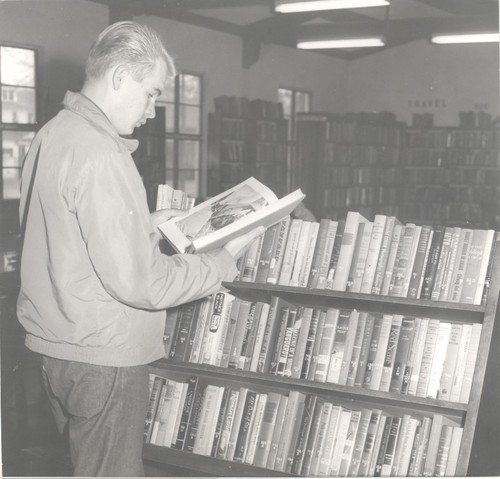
[144,211,500,477]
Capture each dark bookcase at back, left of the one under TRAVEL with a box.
[297,113,405,219]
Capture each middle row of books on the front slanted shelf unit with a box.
[164,292,482,403]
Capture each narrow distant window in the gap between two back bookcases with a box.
[278,88,311,190]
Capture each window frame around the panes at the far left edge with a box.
[0,40,42,204]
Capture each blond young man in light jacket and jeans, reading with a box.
[18,22,263,476]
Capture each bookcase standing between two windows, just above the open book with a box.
[207,98,287,196]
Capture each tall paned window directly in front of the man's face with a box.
[157,73,202,197]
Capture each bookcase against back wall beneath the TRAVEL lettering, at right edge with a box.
[401,127,500,228]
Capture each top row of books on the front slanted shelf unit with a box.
[239,211,499,305]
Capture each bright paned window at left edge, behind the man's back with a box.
[0,45,37,200]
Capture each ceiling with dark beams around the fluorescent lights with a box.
[89,0,499,62]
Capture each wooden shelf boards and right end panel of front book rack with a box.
[143,240,500,476]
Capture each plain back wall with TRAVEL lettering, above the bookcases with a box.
[347,41,499,126]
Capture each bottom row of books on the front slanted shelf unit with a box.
[144,373,463,477]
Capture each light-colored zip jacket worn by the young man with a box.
[17,92,237,366]
